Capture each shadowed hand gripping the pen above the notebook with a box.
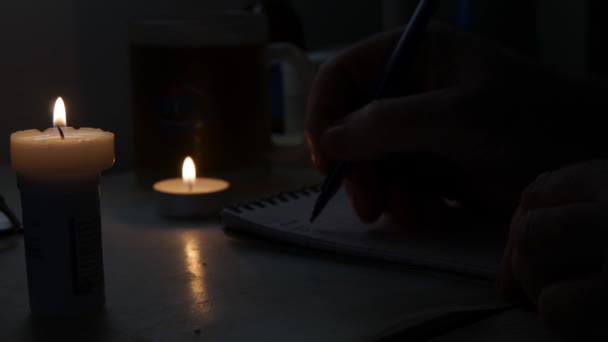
[306,25,600,227]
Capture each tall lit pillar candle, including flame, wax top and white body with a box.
[11,98,114,315]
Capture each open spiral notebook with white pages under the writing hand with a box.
[221,188,505,280]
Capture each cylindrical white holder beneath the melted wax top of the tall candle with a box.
[17,174,105,316]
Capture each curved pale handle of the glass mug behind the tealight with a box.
[267,43,316,146]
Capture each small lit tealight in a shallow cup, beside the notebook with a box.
[153,157,230,218]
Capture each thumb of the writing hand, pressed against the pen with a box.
[320,88,466,161]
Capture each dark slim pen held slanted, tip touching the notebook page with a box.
[310,0,438,222]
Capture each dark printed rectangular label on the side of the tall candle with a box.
[70,217,103,294]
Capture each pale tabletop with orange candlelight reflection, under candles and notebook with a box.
[0,167,552,342]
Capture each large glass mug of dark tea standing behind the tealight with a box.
[129,12,313,187]
